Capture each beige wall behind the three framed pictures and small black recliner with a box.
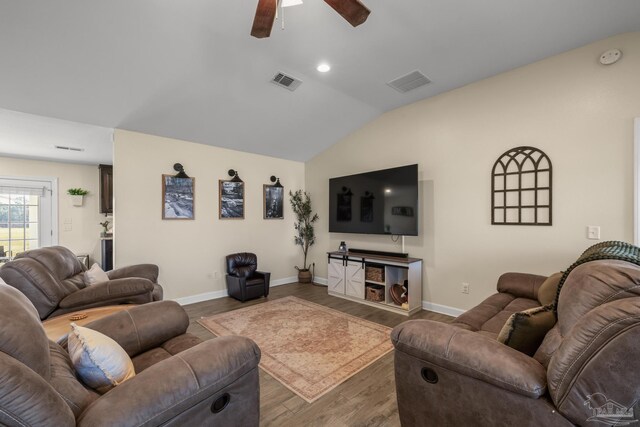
[114,130,304,299]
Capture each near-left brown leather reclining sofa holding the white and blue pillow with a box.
[0,284,260,427]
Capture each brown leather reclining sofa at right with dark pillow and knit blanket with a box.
[392,260,640,427]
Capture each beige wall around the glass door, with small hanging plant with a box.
[0,157,105,263]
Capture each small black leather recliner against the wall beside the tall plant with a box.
[226,252,271,302]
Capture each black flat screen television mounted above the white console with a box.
[329,165,419,236]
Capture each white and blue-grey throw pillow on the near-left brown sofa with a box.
[67,323,136,393]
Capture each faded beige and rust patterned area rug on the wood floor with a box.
[199,297,392,403]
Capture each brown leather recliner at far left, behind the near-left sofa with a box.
[0,246,162,320]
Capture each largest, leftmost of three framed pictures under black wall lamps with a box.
[162,175,196,219]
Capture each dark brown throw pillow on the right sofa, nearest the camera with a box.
[498,304,556,356]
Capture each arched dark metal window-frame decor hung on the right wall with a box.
[491,146,552,225]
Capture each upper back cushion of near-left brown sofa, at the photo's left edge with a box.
[0,284,51,381]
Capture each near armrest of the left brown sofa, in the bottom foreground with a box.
[78,336,260,427]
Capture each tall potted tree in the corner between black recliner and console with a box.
[289,190,318,283]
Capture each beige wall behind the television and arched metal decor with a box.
[305,33,640,309]
